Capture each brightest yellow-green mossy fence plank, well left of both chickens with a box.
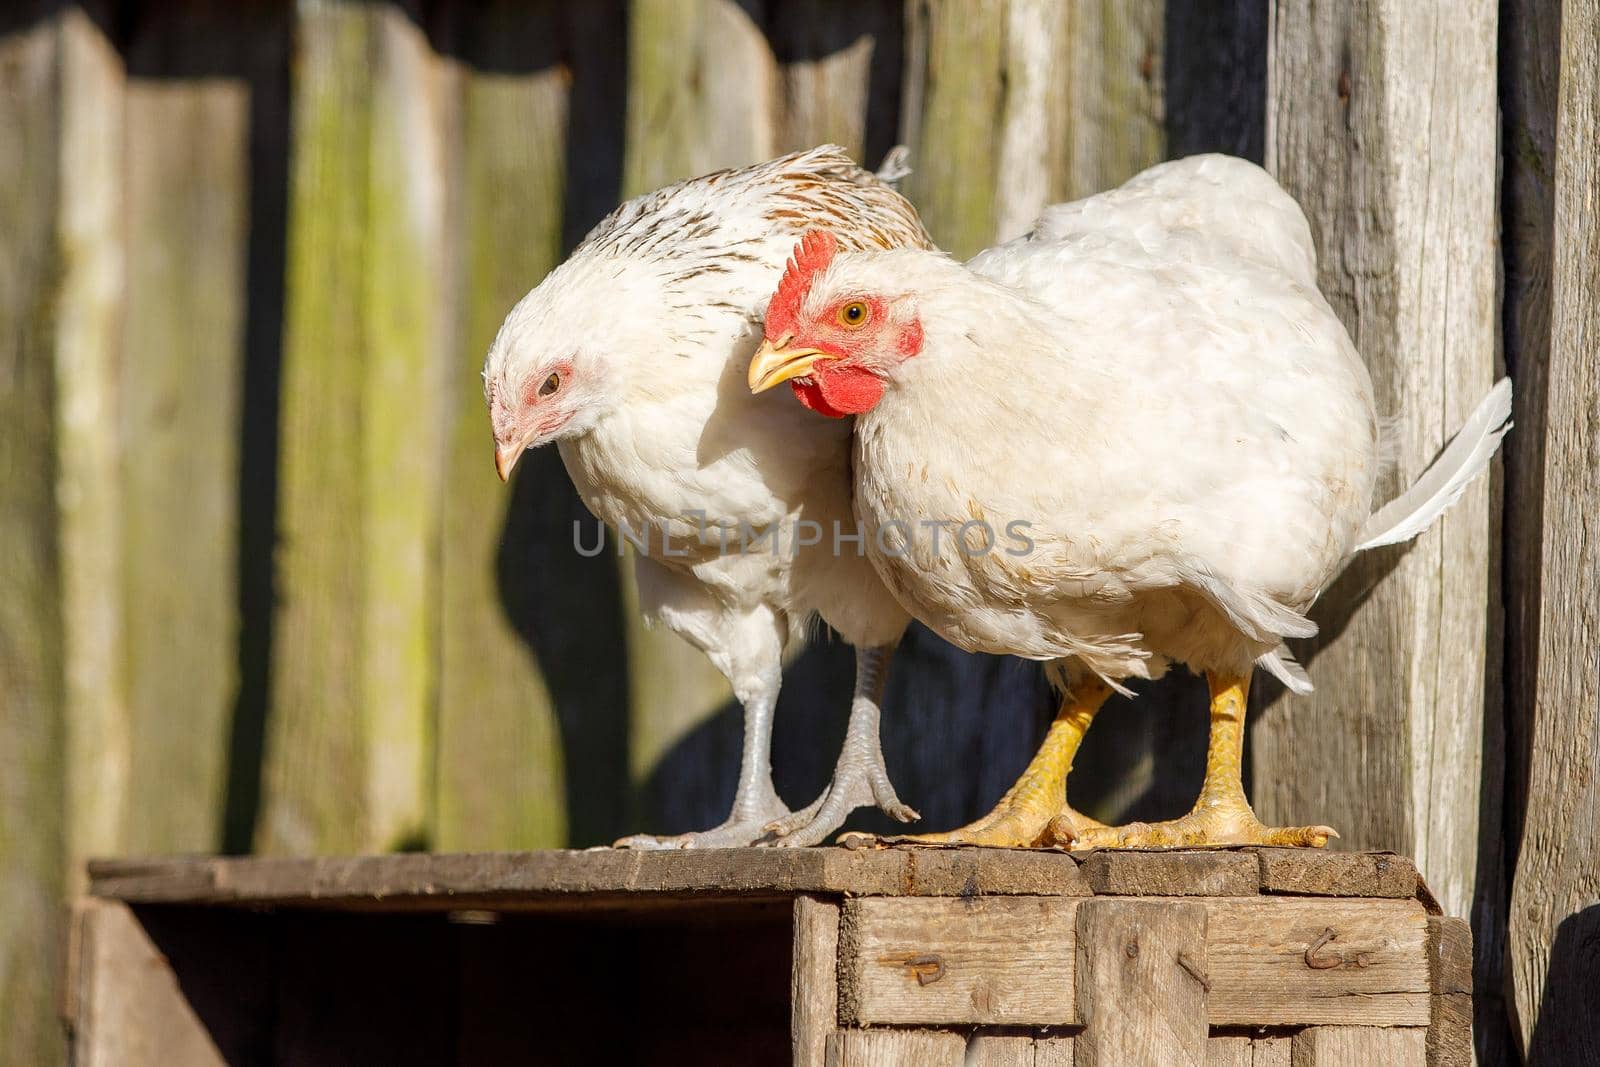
[258,0,448,853]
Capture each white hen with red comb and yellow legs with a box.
[749,155,1510,848]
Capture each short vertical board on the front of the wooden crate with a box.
[1072,899,1211,1067]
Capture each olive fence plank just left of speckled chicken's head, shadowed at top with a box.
[434,3,569,851]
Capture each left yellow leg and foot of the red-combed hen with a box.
[885,678,1110,848]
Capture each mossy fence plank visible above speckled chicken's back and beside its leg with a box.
[621,0,778,830]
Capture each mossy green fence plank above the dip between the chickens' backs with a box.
[901,0,1006,259]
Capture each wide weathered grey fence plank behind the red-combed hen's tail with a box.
[1253,0,1499,913]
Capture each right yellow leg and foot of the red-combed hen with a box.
[1045,670,1339,849]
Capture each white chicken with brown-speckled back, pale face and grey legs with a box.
[483,146,931,848]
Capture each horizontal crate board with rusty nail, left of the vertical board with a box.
[838,897,1077,1025]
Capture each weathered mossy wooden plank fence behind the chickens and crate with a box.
[0,0,1600,1064]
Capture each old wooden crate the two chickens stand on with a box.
[75,848,1472,1067]
